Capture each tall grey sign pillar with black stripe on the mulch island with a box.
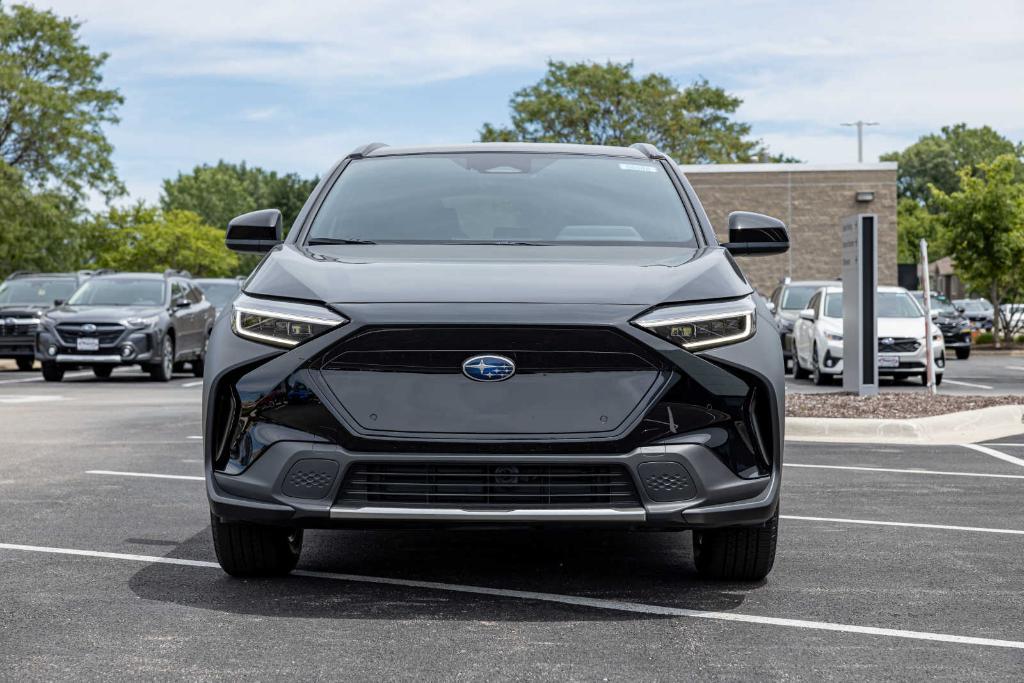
[843,213,879,396]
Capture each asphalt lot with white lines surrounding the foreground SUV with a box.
[0,370,1024,681]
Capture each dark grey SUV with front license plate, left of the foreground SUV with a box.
[36,270,215,382]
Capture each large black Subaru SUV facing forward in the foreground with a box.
[203,143,788,580]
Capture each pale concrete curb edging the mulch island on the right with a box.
[785,405,1024,445]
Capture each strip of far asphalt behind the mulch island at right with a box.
[785,352,1024,394]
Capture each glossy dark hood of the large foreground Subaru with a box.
[244,245,753,305]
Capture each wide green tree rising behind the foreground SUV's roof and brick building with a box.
[479,60,795,164]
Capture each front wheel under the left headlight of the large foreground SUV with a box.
[210,513,301,577]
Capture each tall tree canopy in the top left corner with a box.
[0,5,124,198]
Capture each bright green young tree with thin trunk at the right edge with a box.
[932,154,1024,344]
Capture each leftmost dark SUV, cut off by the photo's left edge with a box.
[0,270,96,370]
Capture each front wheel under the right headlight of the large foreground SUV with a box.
[693,510,778,581]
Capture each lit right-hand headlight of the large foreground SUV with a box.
[633,299,755,351]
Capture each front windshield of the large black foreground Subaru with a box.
[306,153,697,247]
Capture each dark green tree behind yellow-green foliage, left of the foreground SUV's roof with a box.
[160,161,317,229]
